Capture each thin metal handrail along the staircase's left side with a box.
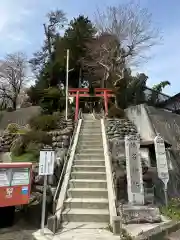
[53,109,82,214]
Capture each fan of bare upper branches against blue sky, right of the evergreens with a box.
[96,2,160,65]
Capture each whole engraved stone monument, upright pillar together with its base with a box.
[123,135,161,224]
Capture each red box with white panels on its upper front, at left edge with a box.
[0,163,32,207]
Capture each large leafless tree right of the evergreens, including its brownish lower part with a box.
[92,2,160,85]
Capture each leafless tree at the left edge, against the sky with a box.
[0,52,27,110]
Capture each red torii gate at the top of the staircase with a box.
[69,88,114,120]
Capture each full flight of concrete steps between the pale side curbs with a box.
[62,114,110,224]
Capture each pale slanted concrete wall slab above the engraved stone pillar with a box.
[125,104,156,141]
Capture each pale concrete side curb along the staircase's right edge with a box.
[101,118,117,232]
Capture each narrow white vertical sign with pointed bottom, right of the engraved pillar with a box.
[154,135,169,185]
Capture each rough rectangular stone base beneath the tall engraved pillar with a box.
[123,205,162,224]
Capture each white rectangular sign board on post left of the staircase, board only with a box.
[39,150,55,175]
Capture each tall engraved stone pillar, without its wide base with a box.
[125,136,144,205]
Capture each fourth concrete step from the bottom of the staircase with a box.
[69,179,107,188]
